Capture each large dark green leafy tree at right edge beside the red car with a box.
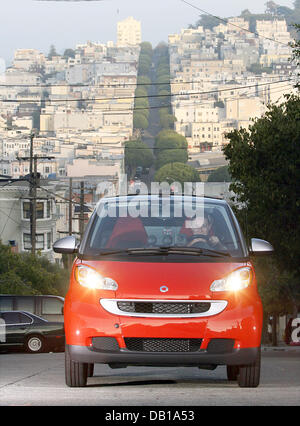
[224,96,300,318]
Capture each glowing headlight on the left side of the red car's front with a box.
[75,265,118,291]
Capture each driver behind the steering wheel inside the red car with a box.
[186,215,226,250]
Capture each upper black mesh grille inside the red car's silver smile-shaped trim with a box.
[117,301,210,315]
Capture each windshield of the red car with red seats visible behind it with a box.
[84,197,243,257]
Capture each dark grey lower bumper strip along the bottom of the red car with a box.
[67,345,259,367]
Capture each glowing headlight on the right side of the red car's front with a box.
[210,266,253,291]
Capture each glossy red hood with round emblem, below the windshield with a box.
[83,261,245,300]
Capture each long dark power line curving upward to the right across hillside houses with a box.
[0,78,293,103]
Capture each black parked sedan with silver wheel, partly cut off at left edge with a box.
[0,311,65,353]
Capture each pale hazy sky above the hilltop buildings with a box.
[0,0,293,65]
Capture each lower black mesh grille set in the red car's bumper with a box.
[124,337,202,352]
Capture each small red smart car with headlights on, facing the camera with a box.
[54,195,273,387]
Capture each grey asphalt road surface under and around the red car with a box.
[0,350,300,407]
